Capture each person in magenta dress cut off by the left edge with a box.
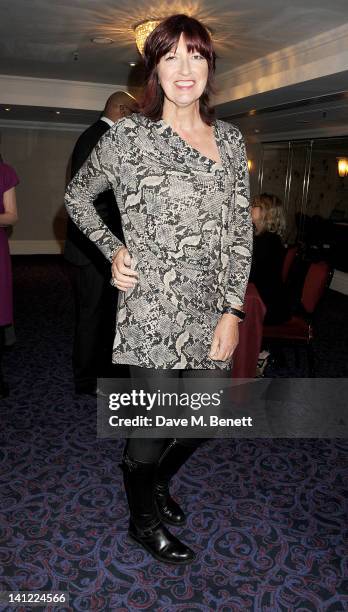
[0,156,18,399]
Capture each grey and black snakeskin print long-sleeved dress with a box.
[65,114,252,370]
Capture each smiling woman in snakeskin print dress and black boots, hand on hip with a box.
[66,15,252,563]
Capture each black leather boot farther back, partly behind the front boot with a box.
[155,439,197,525]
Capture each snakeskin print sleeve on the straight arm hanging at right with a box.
[224,130,253,307]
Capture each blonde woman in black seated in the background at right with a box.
[250,193,291,325]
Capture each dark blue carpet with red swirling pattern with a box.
[0,257,348,612]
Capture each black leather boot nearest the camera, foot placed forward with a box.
[120,454,195,564]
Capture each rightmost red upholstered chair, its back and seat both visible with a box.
[263,261,333,377]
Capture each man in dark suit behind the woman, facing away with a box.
[64,91,137,395]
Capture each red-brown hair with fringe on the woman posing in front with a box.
[141,15,216,125]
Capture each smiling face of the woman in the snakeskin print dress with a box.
[157,34,208,107]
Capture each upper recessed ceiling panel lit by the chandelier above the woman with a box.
[0,0,347,85]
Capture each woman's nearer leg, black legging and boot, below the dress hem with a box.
[121,366,195,564]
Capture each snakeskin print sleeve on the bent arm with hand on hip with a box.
[64,129,124,261]
